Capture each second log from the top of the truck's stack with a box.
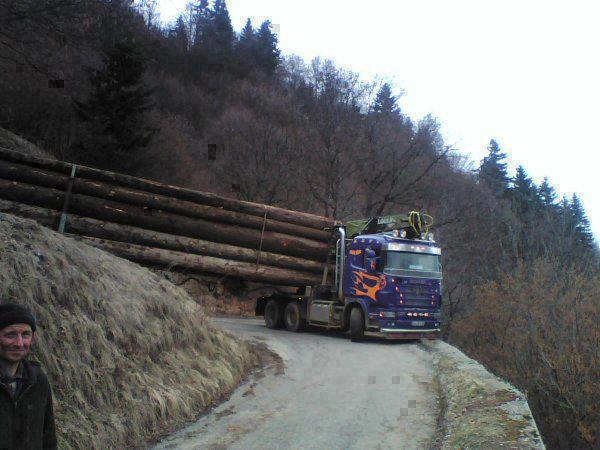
[0,160,331,242]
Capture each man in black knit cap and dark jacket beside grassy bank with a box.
[0,303,57,450]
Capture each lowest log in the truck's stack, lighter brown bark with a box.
[75,236,320,286]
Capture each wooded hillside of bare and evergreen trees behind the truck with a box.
[0,0,600,449]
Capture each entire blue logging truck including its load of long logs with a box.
[0,147,442,341]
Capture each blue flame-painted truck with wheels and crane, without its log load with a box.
[255,212,442,341]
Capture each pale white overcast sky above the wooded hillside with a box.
[158,0,600,238]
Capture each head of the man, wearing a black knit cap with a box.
[0,303,36,364]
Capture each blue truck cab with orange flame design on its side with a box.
[343,233,442,339]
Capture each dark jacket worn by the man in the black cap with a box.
[0,361,57,450]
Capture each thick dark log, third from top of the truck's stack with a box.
[0,179,329,262]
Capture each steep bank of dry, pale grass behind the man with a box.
[0,214,257,449]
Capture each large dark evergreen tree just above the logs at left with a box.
[75,42,154,171]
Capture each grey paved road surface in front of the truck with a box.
[155,319,437,450]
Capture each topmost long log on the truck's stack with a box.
[0,148,335,230]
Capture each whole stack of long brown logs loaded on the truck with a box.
[0,148,334,286]
